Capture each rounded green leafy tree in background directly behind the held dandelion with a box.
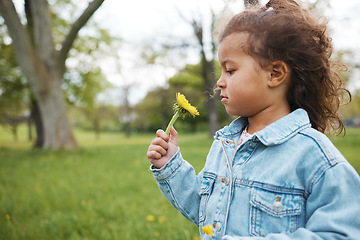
[133,63,225,132]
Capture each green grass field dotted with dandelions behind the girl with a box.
[0,126,360,240]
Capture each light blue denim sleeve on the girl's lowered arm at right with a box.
[222,162,360,240]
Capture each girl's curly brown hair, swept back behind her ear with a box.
[220,0,351,133]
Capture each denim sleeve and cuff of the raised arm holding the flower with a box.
[150,149,200,226]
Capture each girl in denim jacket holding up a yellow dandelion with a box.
[147,0,360,240]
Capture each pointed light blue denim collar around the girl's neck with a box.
[214,108,311,146]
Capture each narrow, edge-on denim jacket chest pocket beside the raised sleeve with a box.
[199,177,215,226]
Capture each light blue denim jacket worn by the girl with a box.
[150,109,360,240]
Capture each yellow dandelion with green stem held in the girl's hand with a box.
[165,93,200,135]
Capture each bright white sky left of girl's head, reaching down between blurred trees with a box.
[95,0,228,104]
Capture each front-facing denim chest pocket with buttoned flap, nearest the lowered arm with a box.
[250,188,304,237]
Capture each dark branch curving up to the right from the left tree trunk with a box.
[57,0,104,75]
